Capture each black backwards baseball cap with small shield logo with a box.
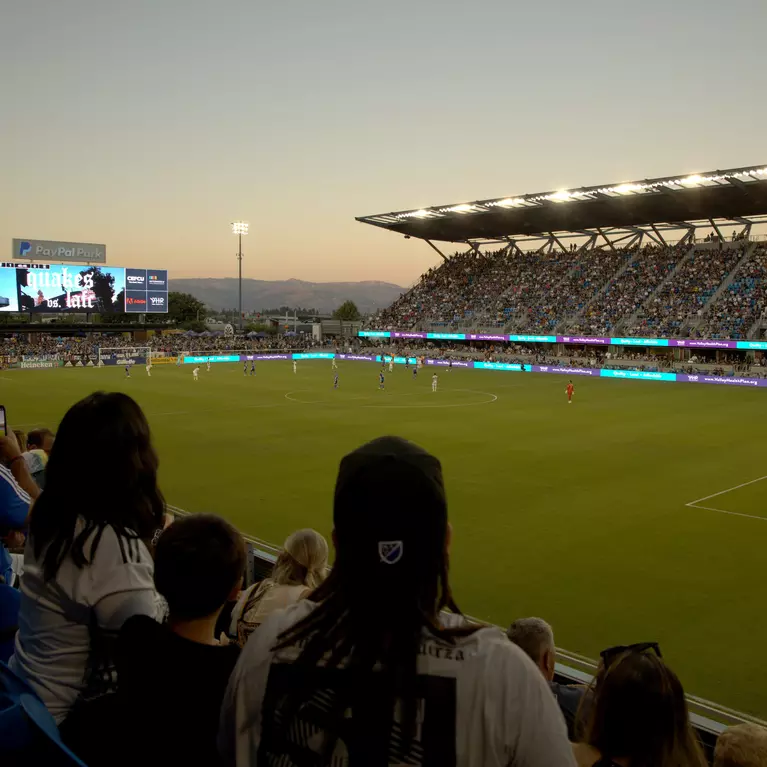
[333,437,447,578]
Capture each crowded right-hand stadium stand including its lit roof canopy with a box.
[357,166,767,339]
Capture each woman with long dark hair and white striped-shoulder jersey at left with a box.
[12,392,165,756]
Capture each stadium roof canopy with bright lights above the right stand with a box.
[357,165,767,254]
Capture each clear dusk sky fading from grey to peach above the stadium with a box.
[0,0,767,285]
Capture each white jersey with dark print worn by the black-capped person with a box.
[219,600,575,767]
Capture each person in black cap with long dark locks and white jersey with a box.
[219,437,574,767]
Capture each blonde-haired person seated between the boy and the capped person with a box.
[229,528,328,647]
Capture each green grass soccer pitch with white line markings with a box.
[6,360,767,718]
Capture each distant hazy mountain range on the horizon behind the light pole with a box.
[169,277,405,313]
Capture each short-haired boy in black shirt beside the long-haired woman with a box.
[116,514,245,767]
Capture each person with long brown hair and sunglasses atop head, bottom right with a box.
[573,642,706,767]
